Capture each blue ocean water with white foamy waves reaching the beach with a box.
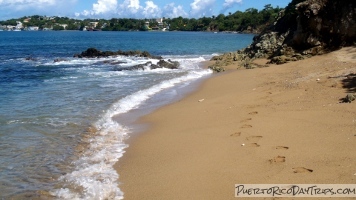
[0,31,253,199]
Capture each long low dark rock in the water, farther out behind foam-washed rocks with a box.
[74,48,162,59]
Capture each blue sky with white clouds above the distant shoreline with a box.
[0,0,291,20]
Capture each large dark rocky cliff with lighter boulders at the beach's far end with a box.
[212,0,356,71]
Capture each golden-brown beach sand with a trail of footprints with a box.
[115,48,356,200]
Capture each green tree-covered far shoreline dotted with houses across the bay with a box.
[0,4,282,32]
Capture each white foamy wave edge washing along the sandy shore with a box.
[51,55,212,200]
